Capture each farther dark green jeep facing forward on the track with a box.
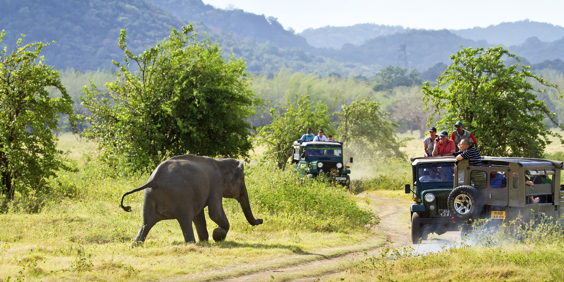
[292,141,353,187]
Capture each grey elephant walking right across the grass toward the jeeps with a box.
[121,155,263,244]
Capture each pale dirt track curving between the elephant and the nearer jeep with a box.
[176,193,460,282]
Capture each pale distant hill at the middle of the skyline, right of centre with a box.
[299,24,405,49]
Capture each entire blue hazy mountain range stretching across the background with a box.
[0,0,564,76]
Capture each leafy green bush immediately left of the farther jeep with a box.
[258,95,332,169]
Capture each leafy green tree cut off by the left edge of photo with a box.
[0,31,76,200]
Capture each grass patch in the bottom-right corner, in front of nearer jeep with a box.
[329,216,564,281]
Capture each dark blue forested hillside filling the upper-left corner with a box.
[0,0,185,70]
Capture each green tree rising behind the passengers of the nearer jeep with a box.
[422,47,563,157]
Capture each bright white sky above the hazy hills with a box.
[203,0,564,33]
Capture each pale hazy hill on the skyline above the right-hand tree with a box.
[451,20,564,46]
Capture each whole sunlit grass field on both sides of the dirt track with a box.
[0,131,564,281]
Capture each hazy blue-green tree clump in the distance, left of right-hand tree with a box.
[374,65,423,91]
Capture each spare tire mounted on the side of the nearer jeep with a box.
[448,186,484,221]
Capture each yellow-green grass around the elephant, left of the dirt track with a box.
[0,134,385,281]
